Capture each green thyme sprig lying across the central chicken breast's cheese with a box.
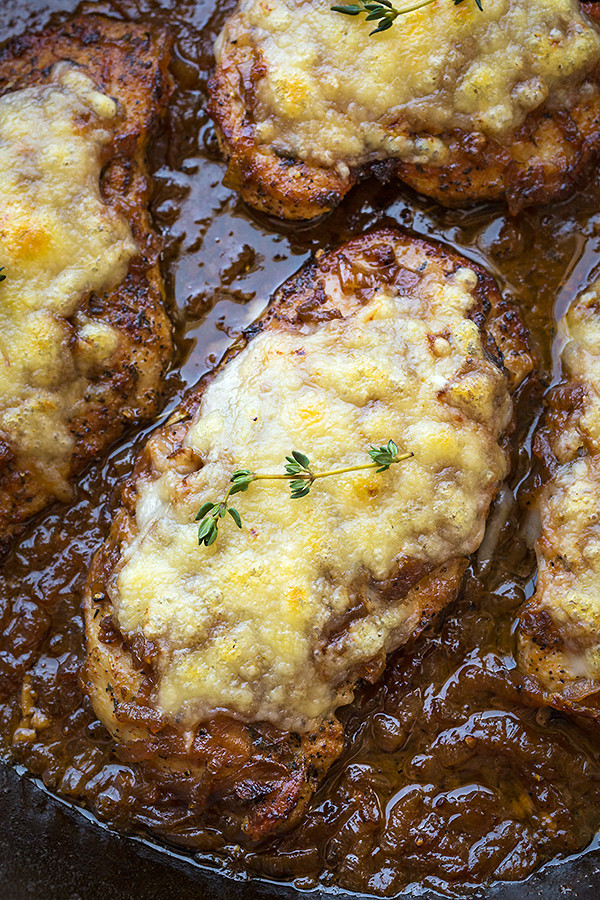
[195,440,414,547]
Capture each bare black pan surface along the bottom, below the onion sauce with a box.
[0,766,600,900]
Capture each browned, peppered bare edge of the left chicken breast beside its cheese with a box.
[0,16,172,545]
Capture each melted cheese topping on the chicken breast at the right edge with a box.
[535,282,600,679]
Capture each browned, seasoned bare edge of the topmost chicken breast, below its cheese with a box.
[208,3,600,219]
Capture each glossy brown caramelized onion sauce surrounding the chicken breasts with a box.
[0,0,600,896]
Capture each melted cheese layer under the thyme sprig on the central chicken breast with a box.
[110,258,512,729]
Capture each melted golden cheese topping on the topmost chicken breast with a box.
[216,0,600,168]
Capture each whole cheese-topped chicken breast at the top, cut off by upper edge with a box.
[209,0,600,219]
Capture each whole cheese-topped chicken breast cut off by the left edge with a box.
[0,16,171,545]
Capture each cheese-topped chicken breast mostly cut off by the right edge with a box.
[519,282,600,717]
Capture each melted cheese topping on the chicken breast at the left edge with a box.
[0,64,136,496]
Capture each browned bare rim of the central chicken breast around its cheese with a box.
[84,231,533,841]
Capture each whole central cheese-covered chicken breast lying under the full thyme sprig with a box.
[84,231,532,839]
